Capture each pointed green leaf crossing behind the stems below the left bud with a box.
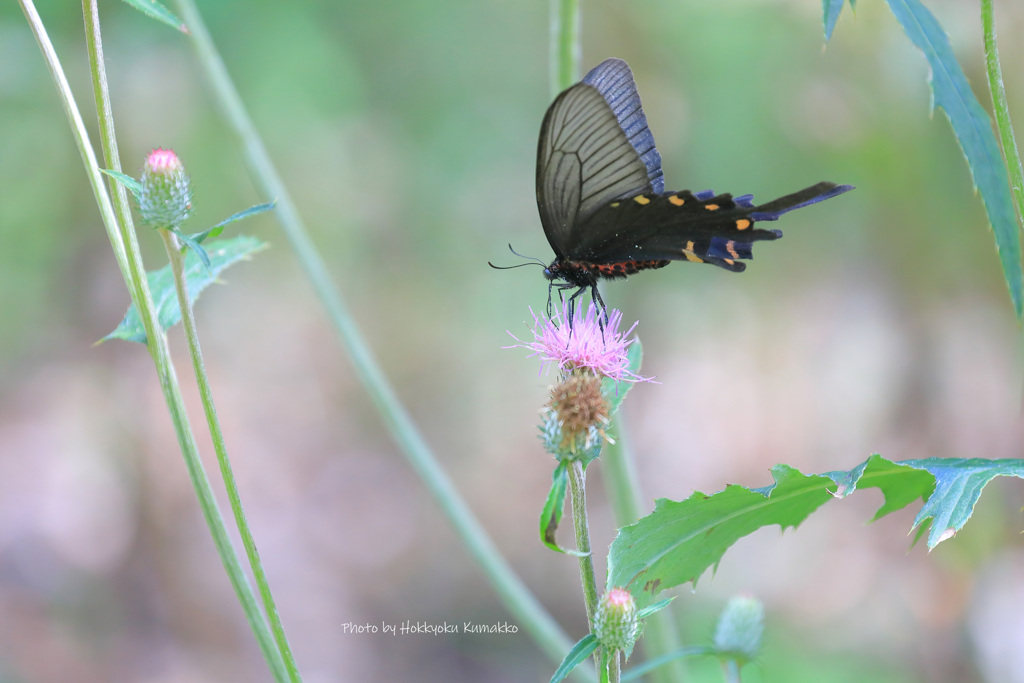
[100,236,267,344]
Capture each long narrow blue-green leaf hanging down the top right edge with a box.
[888,0,1024,318]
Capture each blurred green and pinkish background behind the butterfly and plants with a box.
[0,0,1024,683]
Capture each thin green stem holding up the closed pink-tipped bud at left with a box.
[158,229,302,683]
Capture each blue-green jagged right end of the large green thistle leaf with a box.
[900,458,1024,549]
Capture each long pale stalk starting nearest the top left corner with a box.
[19,0,286,682]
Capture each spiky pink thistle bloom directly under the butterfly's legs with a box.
[506,301,651,382]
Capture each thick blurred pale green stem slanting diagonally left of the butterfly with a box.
[169,0,585,663]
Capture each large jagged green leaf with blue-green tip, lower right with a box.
[607,456,1024,606]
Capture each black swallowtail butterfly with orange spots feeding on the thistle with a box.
[537,59,853,321]
